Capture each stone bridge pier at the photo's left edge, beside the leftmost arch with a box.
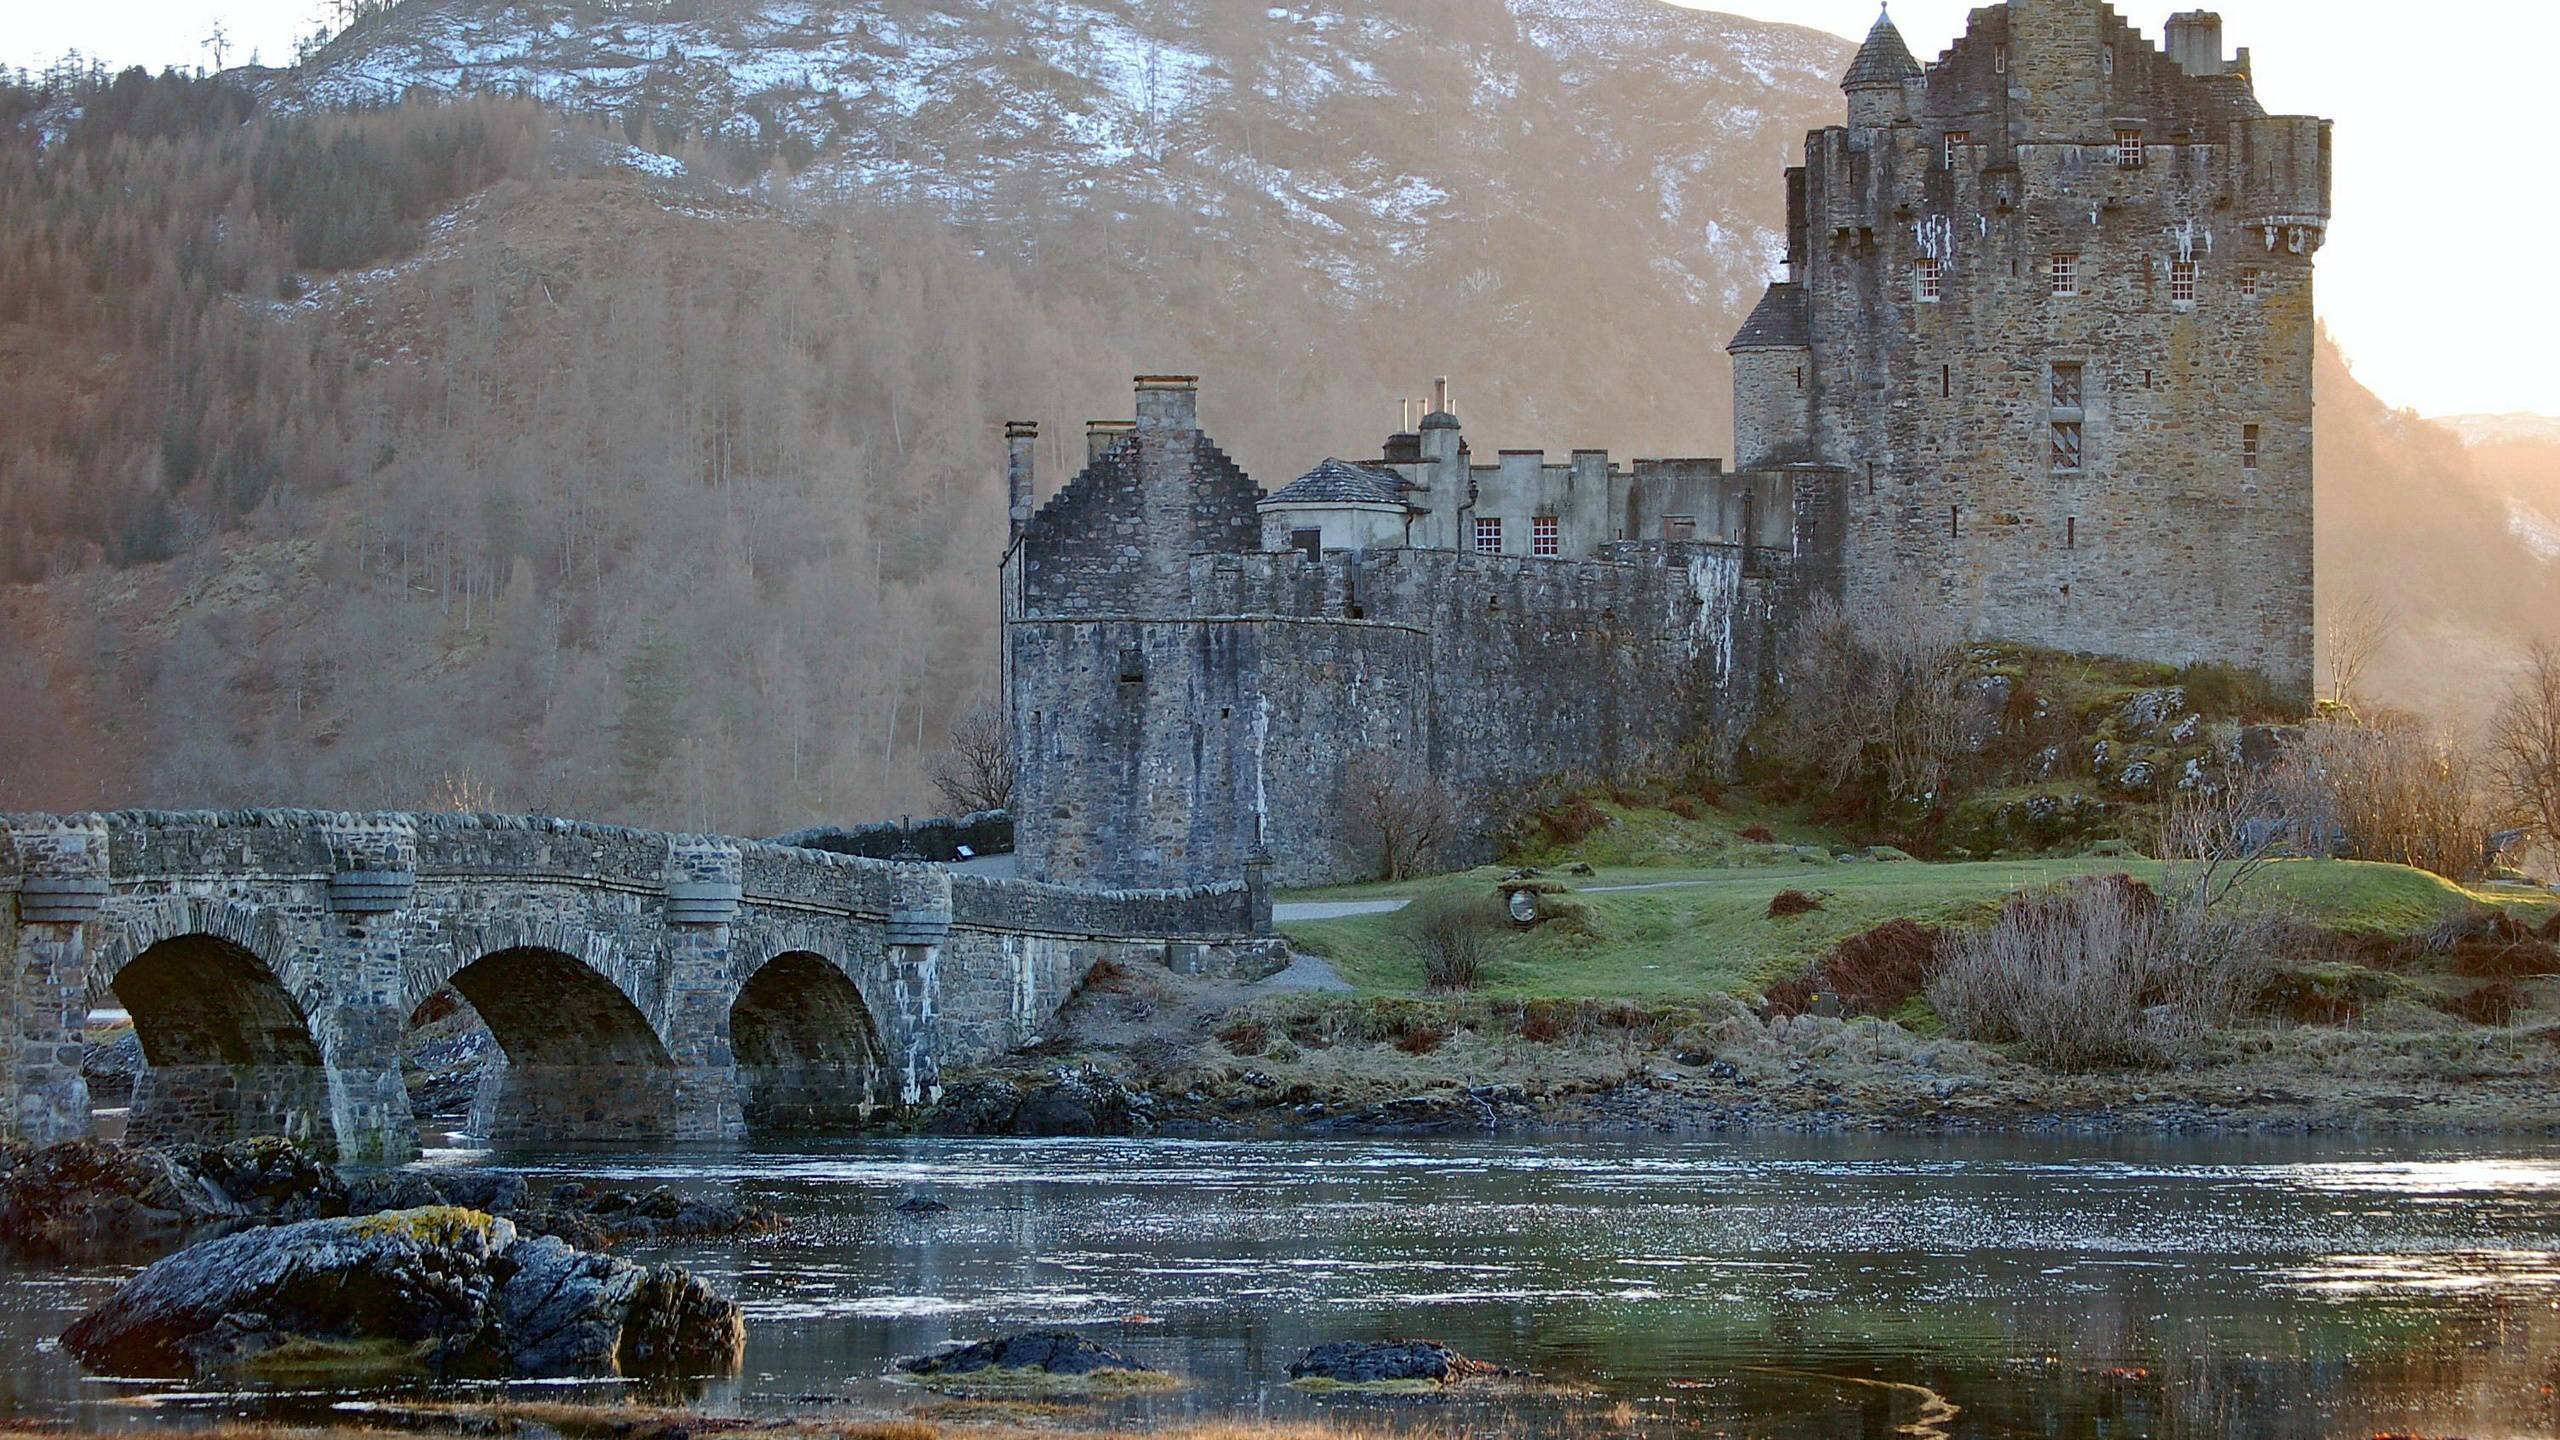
[5,820,108,1145]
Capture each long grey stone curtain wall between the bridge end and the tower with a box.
[1009,540,1797,884]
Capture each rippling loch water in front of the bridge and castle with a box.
[0,1138,2560,1437]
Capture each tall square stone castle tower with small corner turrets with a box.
[1728,0,2330,702]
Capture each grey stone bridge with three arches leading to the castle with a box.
[0,810,1270,1161]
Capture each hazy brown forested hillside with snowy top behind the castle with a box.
[0,0,2560,833]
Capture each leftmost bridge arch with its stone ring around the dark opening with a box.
[92,902,340,1156]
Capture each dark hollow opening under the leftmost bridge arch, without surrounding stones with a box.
[108,935,338,1156]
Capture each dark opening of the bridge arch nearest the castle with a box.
[730,951,891,1135]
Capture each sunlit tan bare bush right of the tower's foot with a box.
[2271,715,2488,879]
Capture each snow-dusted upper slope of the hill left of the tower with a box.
[269,0,1848,304]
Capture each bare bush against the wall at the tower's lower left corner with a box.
[1764,600,1964,819]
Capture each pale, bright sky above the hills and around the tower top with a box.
[0,0,2560,415]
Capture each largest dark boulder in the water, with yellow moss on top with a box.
[61,1207,745,1379]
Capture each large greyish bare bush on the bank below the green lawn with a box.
[1928,876,2276,1071]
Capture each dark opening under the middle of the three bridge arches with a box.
[448,945,676,1143]
